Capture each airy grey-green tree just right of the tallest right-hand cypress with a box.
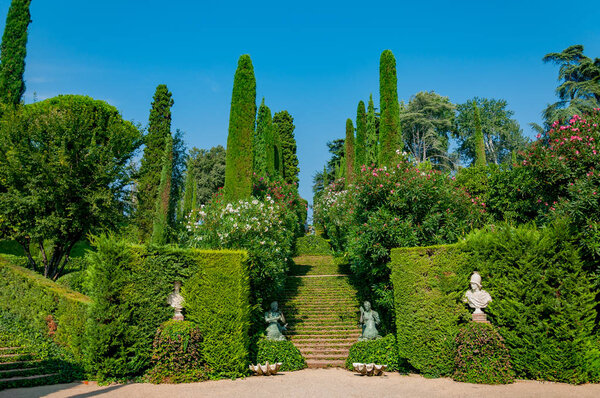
[400,91,454,165]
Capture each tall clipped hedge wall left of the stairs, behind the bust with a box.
[85,237,250,380]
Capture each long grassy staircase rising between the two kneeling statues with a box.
[283,256,360,368]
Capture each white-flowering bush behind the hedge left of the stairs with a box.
[186,196,297,303]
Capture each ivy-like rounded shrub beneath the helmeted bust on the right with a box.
[452,322,514,384]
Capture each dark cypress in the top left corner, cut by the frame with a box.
[0,0,31,105]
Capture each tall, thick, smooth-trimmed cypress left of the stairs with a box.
[224,54,256,202]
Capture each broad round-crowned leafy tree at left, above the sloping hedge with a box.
[0,95,142,279]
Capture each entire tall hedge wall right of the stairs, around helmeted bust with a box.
[392,222,600,383]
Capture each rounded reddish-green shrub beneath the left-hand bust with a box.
[147,320,207,384]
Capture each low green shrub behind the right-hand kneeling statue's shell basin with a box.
[346,334,407,372]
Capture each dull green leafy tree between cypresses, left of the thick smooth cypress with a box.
[188,145,226,207]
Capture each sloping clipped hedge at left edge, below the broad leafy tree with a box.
[0,257,90,358]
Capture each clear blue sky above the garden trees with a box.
[0,0,600,205]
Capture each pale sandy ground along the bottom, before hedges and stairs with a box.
[0,369,600,398]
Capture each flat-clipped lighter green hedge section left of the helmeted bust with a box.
[391,246,470,377]
